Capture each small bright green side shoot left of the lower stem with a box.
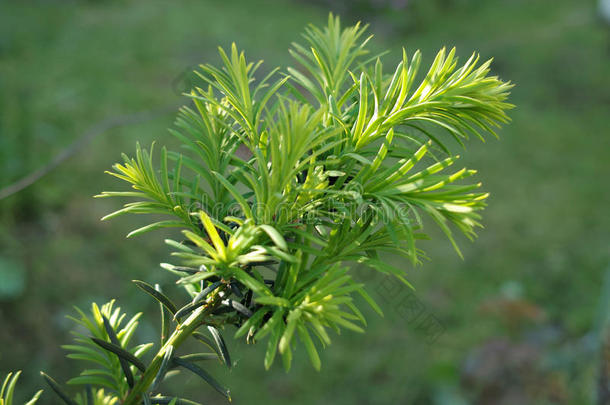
[62,300,153,405]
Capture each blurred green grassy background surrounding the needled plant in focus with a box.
[0,0,610,405]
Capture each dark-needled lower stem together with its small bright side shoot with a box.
[43,294,235,405]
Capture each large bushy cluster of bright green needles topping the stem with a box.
[97,12,512,380]
